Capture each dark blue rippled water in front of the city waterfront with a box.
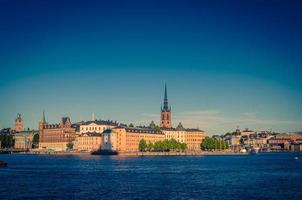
[0,153,302,200]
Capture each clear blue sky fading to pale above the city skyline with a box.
[0,0,302,134]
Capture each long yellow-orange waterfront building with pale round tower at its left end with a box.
[101,127,165,152]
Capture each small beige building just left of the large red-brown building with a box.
[14,130,39,149]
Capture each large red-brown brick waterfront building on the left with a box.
[39,117,76,151]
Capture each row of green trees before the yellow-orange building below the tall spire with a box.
[139,139,187,152]
